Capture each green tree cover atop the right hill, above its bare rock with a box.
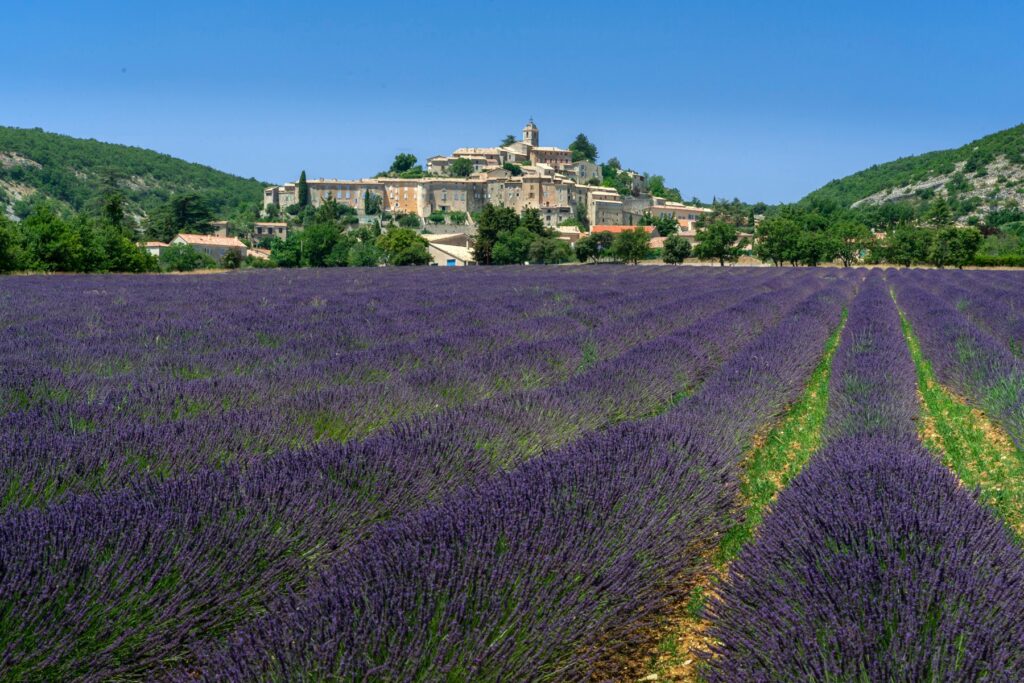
[803,125,1024,207]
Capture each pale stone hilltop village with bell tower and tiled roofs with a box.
[263,120,710,237]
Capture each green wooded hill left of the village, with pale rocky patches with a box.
[0,127,264,222]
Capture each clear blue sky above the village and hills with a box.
[0,0,1024,203]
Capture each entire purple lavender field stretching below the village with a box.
[0,265,1024,681]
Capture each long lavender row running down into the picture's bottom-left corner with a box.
[0,275,821,675]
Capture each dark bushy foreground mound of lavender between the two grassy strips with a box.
[708,435,1024,683]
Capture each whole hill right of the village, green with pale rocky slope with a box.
[803,124,1024,215]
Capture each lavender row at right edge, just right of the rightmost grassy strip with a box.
[893,273,1024,449]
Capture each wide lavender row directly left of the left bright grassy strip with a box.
[186,276,851,681]
